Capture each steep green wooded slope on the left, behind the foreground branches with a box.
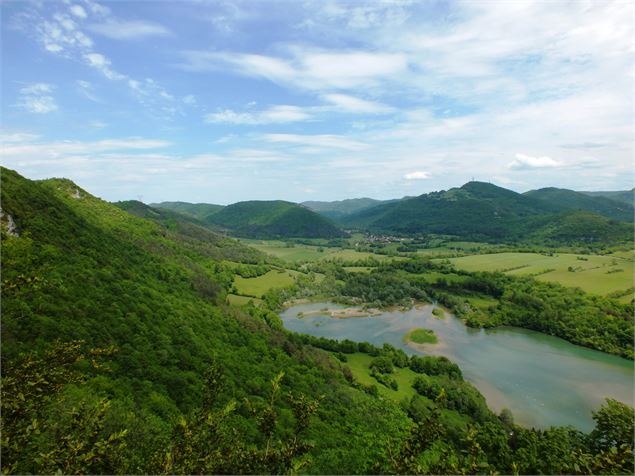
[0,168,409,474]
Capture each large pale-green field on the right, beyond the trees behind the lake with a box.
[450,252,634,300]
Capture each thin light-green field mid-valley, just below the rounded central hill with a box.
[241,240,398,262]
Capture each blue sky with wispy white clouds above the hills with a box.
[0,0,635,204]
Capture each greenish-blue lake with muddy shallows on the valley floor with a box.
[280,302,633,432]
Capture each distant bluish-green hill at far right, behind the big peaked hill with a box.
[523,187,635,222]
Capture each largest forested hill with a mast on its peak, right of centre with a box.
[342,182,632,244]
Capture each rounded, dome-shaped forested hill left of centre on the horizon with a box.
[208,200,346,238]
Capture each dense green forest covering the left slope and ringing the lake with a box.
[0,168,634,474]
